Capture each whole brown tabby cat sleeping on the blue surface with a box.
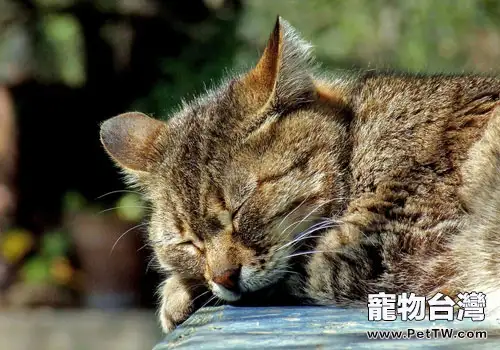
[101,18,500,332]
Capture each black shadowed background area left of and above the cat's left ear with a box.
[11,0,240,231]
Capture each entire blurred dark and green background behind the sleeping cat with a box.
[0,0,500,348]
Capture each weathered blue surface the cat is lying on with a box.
[154,306,500,350]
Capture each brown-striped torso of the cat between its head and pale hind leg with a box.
[320,72,500,294]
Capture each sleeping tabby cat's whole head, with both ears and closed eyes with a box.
[101,19,349,301]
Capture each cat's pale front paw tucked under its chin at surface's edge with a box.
[159,275,202,333]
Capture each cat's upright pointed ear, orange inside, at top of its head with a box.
[237,17,314,109]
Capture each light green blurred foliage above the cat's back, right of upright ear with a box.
[240,0,500,72]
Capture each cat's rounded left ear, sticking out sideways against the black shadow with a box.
[100,112,167,174]
